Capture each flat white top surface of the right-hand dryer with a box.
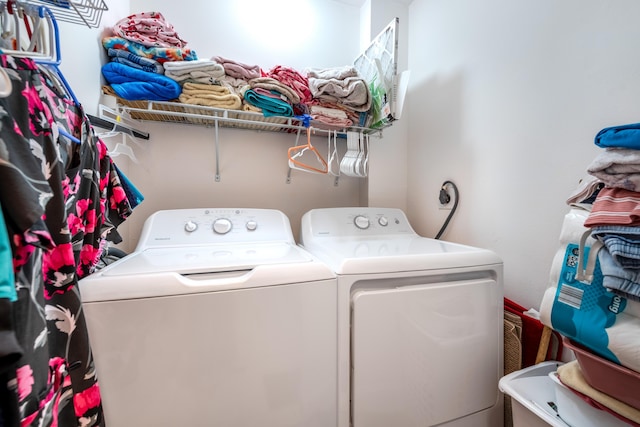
[304,235,502,274]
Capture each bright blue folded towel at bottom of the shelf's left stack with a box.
[102,62,182,101]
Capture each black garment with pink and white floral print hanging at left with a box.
[0,55,132,426]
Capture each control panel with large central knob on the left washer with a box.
[136,208,295,250]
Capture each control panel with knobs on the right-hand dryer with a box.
[301,208,415,237]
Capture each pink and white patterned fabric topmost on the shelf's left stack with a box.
[113,12,187,48]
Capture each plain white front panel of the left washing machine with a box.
[84,280,336,427]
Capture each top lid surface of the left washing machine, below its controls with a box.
[102,242,313,276]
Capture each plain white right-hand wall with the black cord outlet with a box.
[408,0,640,307]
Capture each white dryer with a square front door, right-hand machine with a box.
[300,208,503,427]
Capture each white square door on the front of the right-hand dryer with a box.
[351,279,503,427]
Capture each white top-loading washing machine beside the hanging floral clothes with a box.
[80,209,337,427]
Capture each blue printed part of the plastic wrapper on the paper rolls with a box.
[551,244,627,363]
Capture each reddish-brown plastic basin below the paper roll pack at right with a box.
[563,337,640,410]
